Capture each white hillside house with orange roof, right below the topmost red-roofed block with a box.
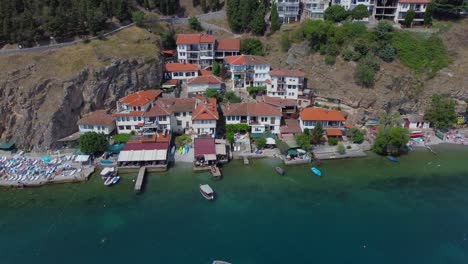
[224,55,270,88]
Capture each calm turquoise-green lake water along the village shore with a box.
[0,146,468,264]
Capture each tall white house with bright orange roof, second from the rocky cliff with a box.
[113,90,161,134]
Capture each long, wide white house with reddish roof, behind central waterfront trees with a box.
[224,102,282,134]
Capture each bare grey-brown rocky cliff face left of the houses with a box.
[0,59,162,150]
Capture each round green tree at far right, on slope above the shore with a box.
[424,95,457,129]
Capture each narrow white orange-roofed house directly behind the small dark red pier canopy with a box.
[192,98,219,137]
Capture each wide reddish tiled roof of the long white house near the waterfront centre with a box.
[224,102,281,116]
